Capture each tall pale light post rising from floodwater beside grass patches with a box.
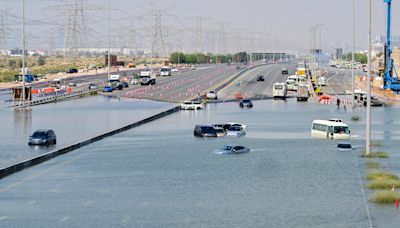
[365,0,372,155]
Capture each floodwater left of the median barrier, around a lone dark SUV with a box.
[0,96,174,167]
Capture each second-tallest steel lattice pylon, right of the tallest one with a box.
[151,11,166,57]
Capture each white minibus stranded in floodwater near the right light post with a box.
[311,119,350,139]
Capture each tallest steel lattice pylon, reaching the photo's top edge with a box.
[67,0,87,57]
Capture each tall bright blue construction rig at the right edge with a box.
[383,0,400,92]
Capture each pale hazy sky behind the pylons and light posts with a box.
[0,0,400,53]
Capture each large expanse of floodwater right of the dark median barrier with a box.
[0,100,400,228]
